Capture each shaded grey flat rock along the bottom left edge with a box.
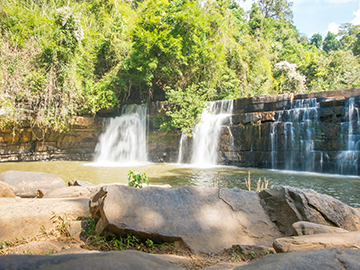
[0,251,183,270]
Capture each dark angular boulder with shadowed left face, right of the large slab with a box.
[259,187,360,236]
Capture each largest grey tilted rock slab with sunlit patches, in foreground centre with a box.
[90,185,281,253]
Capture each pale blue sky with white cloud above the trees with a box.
[240,0,360,38]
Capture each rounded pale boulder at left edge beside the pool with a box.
[0,171,66,198]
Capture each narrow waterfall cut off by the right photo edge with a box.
[337,98,360,175]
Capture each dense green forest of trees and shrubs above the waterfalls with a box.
[0,0,360,135]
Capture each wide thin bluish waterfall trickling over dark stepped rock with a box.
[270,98,319,171]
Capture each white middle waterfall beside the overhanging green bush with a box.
[178,100,233,167]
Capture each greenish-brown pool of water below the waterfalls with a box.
[0,161,360,207]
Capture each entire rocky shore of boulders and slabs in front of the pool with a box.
[0,171,360,269]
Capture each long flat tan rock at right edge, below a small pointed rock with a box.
[273,231,360,253]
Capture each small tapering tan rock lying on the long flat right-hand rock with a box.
[293,221,348,236]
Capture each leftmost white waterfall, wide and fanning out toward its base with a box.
[95,104,148,165]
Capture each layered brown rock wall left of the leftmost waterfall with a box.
[0,116,102,162]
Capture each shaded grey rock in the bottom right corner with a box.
[236,248,360,270]
